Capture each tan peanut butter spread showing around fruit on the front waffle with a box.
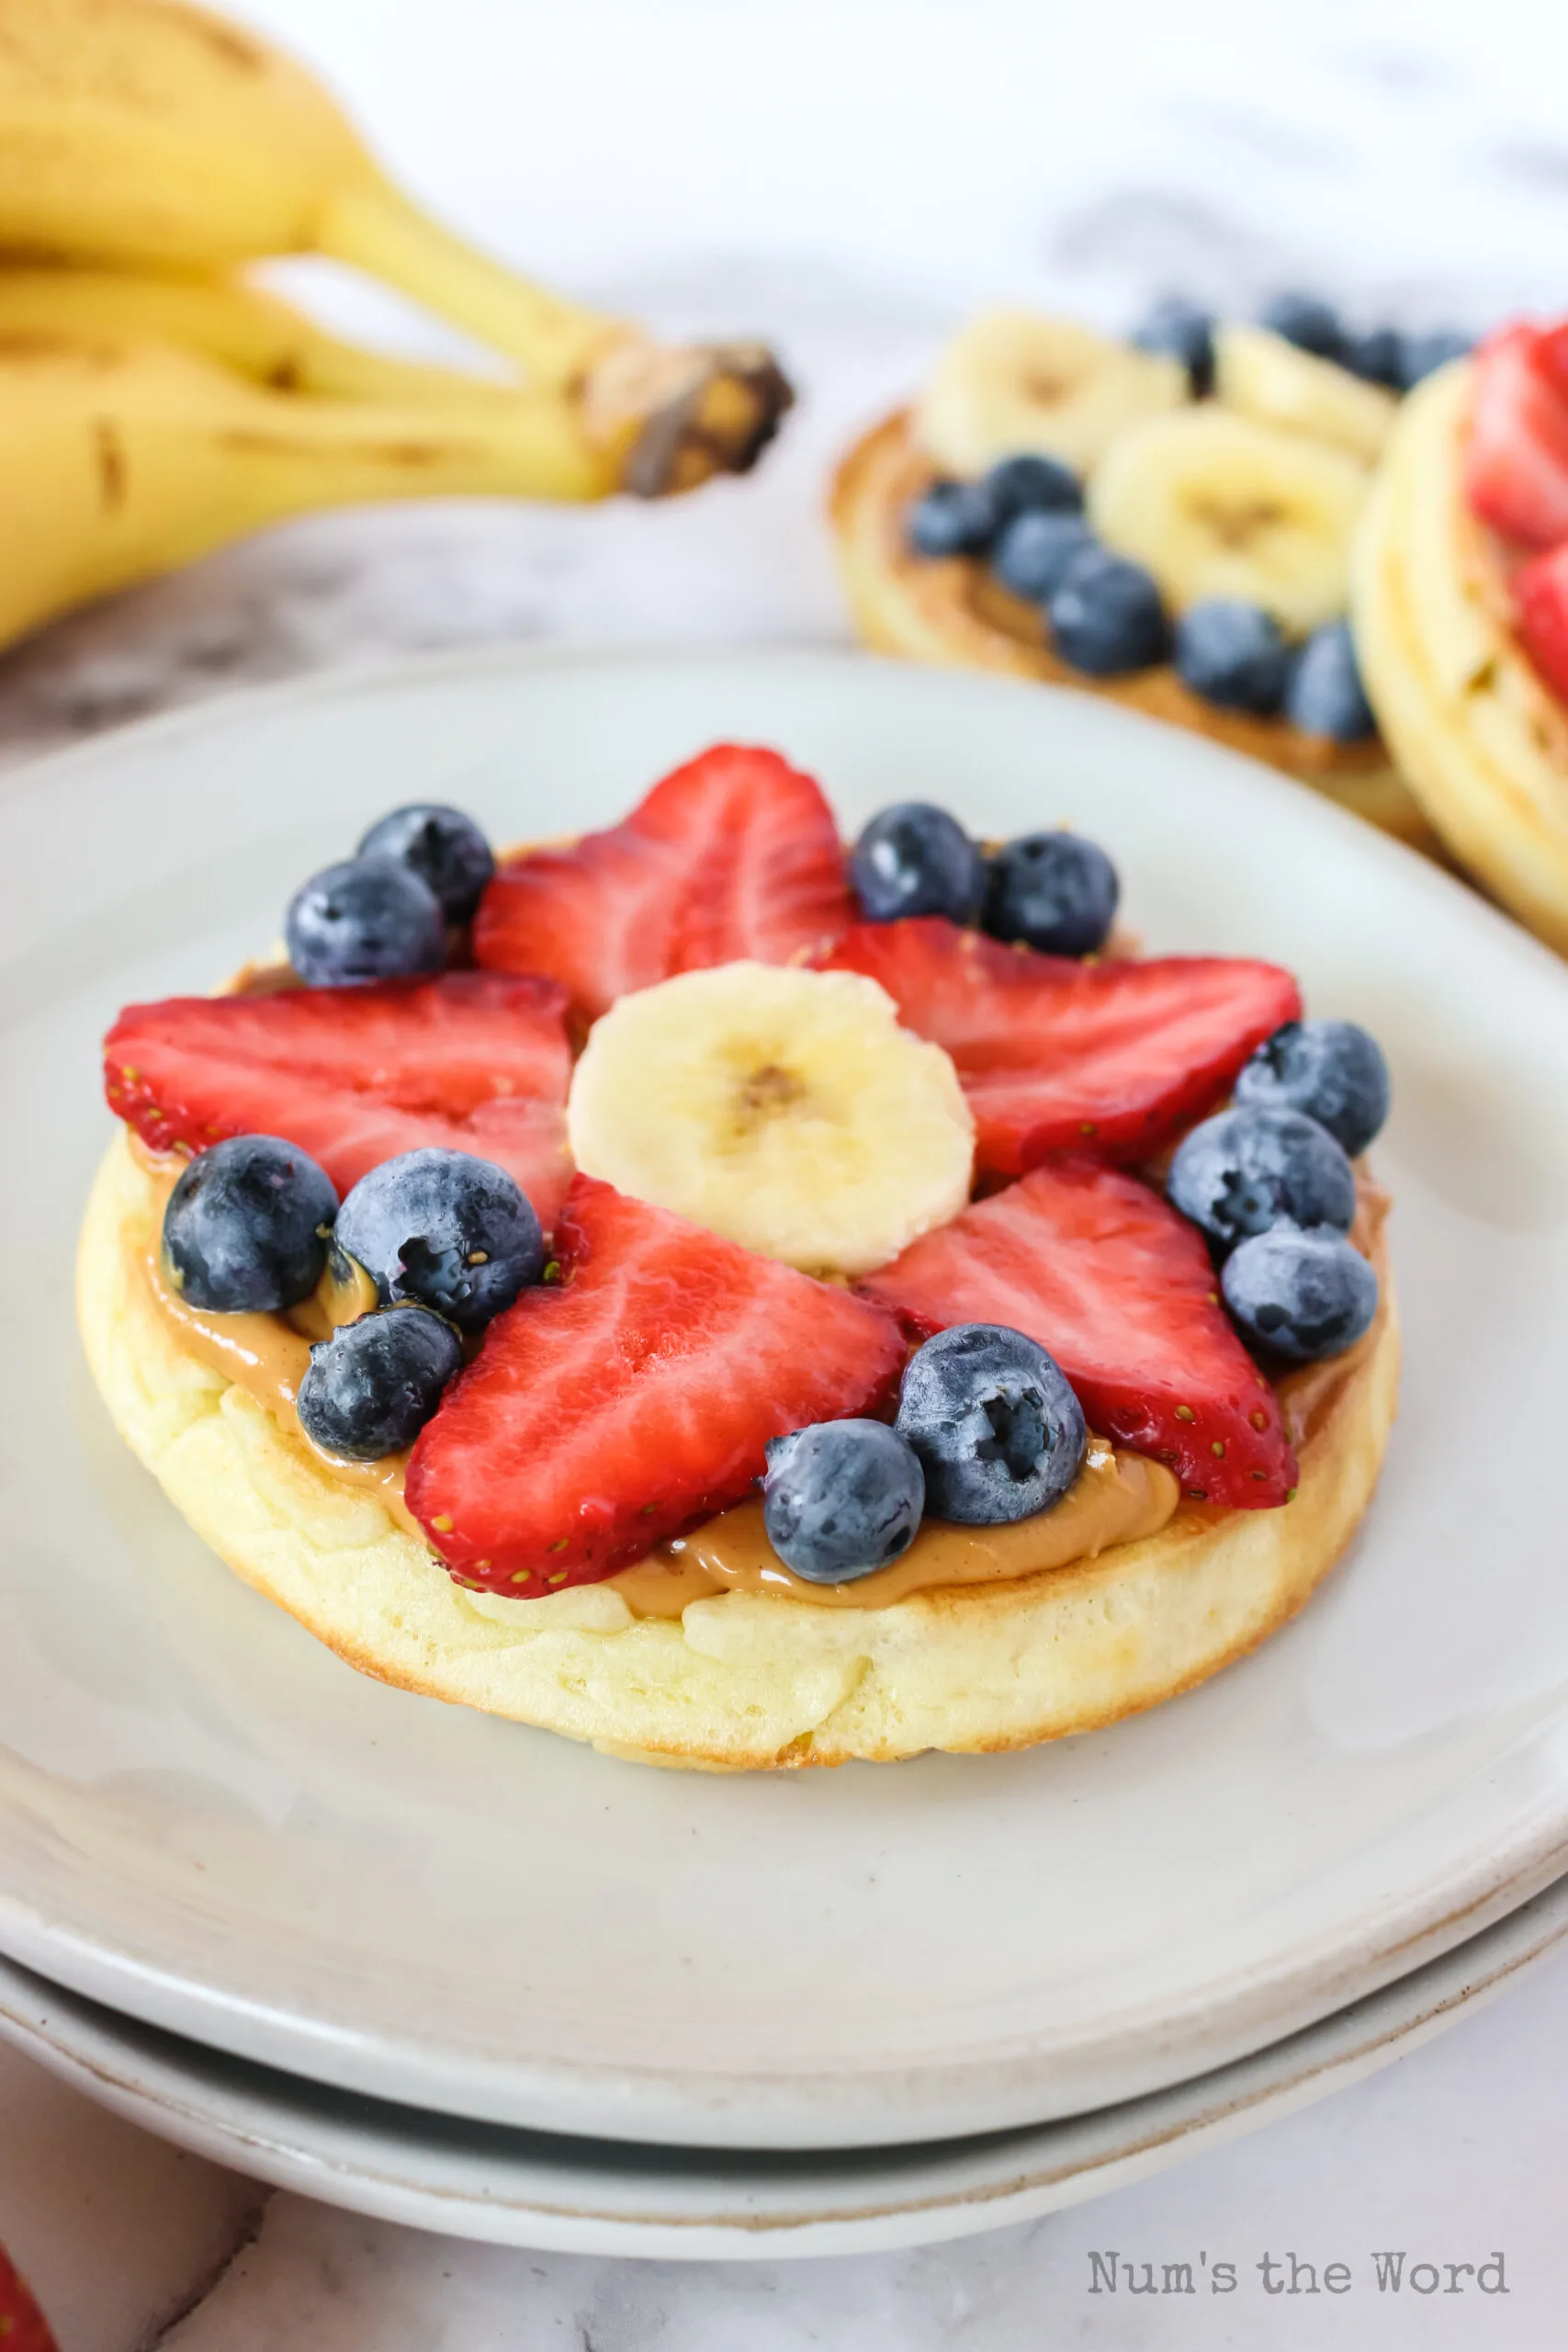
[131,1136,1387,1618]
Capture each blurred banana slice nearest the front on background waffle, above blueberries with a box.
[1089,407,1371,635]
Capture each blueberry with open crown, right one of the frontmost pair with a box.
[896,1324,1089,1526]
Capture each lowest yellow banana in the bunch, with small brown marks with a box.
[0,329,618,644]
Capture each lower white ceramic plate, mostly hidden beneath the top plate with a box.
[0,1879,1568,2263]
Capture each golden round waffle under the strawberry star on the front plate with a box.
[77,1136,1399,1771]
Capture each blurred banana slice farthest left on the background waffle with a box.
[917,311,1190,480]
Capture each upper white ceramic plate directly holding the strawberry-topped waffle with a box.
[0,654,1568,2147]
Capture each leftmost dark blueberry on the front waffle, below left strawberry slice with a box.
[163,1136,339,1315]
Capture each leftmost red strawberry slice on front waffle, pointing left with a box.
[104,971,571,1226]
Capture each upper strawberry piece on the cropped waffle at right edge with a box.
[1464,324,1568,548]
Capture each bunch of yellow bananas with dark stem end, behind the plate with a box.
[0,0,792,662]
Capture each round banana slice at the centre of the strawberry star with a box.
[567,965,974,1275]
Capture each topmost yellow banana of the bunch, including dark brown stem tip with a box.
[0,0,790,492]
